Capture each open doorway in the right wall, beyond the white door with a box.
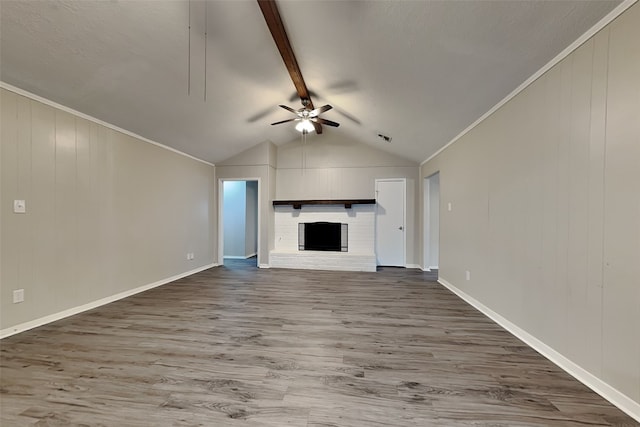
[422,172,440,278]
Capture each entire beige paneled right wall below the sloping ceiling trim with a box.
[421,4,640,419]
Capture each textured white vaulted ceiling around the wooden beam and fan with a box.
[0,0,620,162]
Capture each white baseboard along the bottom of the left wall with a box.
[0,263,218,339]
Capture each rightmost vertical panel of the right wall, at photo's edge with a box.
[603,5,640,402]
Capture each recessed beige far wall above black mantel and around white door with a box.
[276,135,422,267]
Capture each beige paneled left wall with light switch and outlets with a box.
[0,89,216,335]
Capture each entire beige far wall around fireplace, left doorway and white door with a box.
[216,135,422,266]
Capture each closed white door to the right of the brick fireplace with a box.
[376,179,406,267]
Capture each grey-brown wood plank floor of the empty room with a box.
[0,261,638,427]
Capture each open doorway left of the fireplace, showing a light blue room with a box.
[218,179,260,267]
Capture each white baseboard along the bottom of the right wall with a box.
[438,277,640,422]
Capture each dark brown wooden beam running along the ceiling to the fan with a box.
[258,0,314,110]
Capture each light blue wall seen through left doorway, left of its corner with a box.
[222,181,247,258]
